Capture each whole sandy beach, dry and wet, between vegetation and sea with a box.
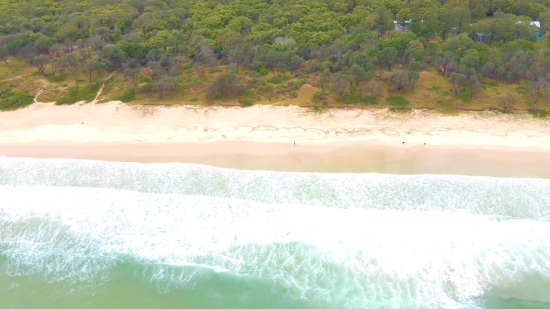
[0,102,550,178]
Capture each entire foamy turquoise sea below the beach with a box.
[0,158,550,309]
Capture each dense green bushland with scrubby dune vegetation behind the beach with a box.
[0,0,550,115]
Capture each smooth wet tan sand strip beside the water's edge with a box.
[0,141,550,179]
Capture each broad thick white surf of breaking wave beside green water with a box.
[0,186,550,308]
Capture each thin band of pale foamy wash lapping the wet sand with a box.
[0,158,550,220]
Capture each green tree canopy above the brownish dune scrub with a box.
[0,0,550,109]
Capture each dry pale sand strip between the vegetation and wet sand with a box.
[0,102,550,150]
